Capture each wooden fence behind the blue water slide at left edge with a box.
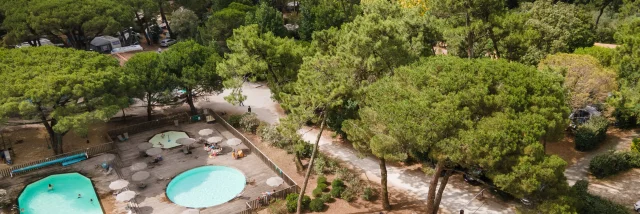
[0,142,116,177]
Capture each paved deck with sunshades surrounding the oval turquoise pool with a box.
[116,122,288,214]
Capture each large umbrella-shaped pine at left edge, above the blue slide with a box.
[0,46,122,154]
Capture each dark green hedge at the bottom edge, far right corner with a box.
[571,180,629,214]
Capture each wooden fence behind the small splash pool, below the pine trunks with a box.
[107,112,191,141]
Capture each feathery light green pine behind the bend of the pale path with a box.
[217,25,307,104]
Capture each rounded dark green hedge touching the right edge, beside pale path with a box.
[589,152,640,178]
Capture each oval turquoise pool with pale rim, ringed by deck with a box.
[167,166,246,208]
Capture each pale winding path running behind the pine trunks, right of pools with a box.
[197,83,515,213]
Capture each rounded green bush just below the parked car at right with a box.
[575,116,609,151]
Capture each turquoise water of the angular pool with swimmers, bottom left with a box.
[18,173,103,214]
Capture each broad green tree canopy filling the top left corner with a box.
[0,0,134,49]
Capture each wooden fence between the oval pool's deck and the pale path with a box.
[207,109,300,214]
